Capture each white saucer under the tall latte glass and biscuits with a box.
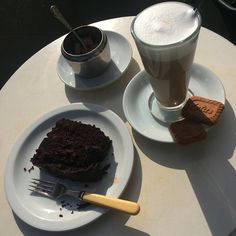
[123,64,225,143]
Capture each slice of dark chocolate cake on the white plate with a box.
[31,119,112,182]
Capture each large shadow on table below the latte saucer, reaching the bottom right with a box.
[133,101,236,236]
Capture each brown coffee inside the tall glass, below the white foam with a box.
[143,52,194,107]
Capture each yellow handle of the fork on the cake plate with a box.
[81,192,140,215]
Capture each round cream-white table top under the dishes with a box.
[0,17,236,236]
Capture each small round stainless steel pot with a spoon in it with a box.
[61,26,111,78]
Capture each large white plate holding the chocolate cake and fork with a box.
[5,103,134,231]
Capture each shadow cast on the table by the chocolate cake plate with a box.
[13,149,146,236]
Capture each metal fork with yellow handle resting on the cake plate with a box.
[28,178,140,215]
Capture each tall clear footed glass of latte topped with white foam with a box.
[131,2,201,122]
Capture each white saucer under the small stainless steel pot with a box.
[57,31,132,91]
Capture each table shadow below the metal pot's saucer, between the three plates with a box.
[65,58,140,121]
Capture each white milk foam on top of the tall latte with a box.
[134,2,199,45]
